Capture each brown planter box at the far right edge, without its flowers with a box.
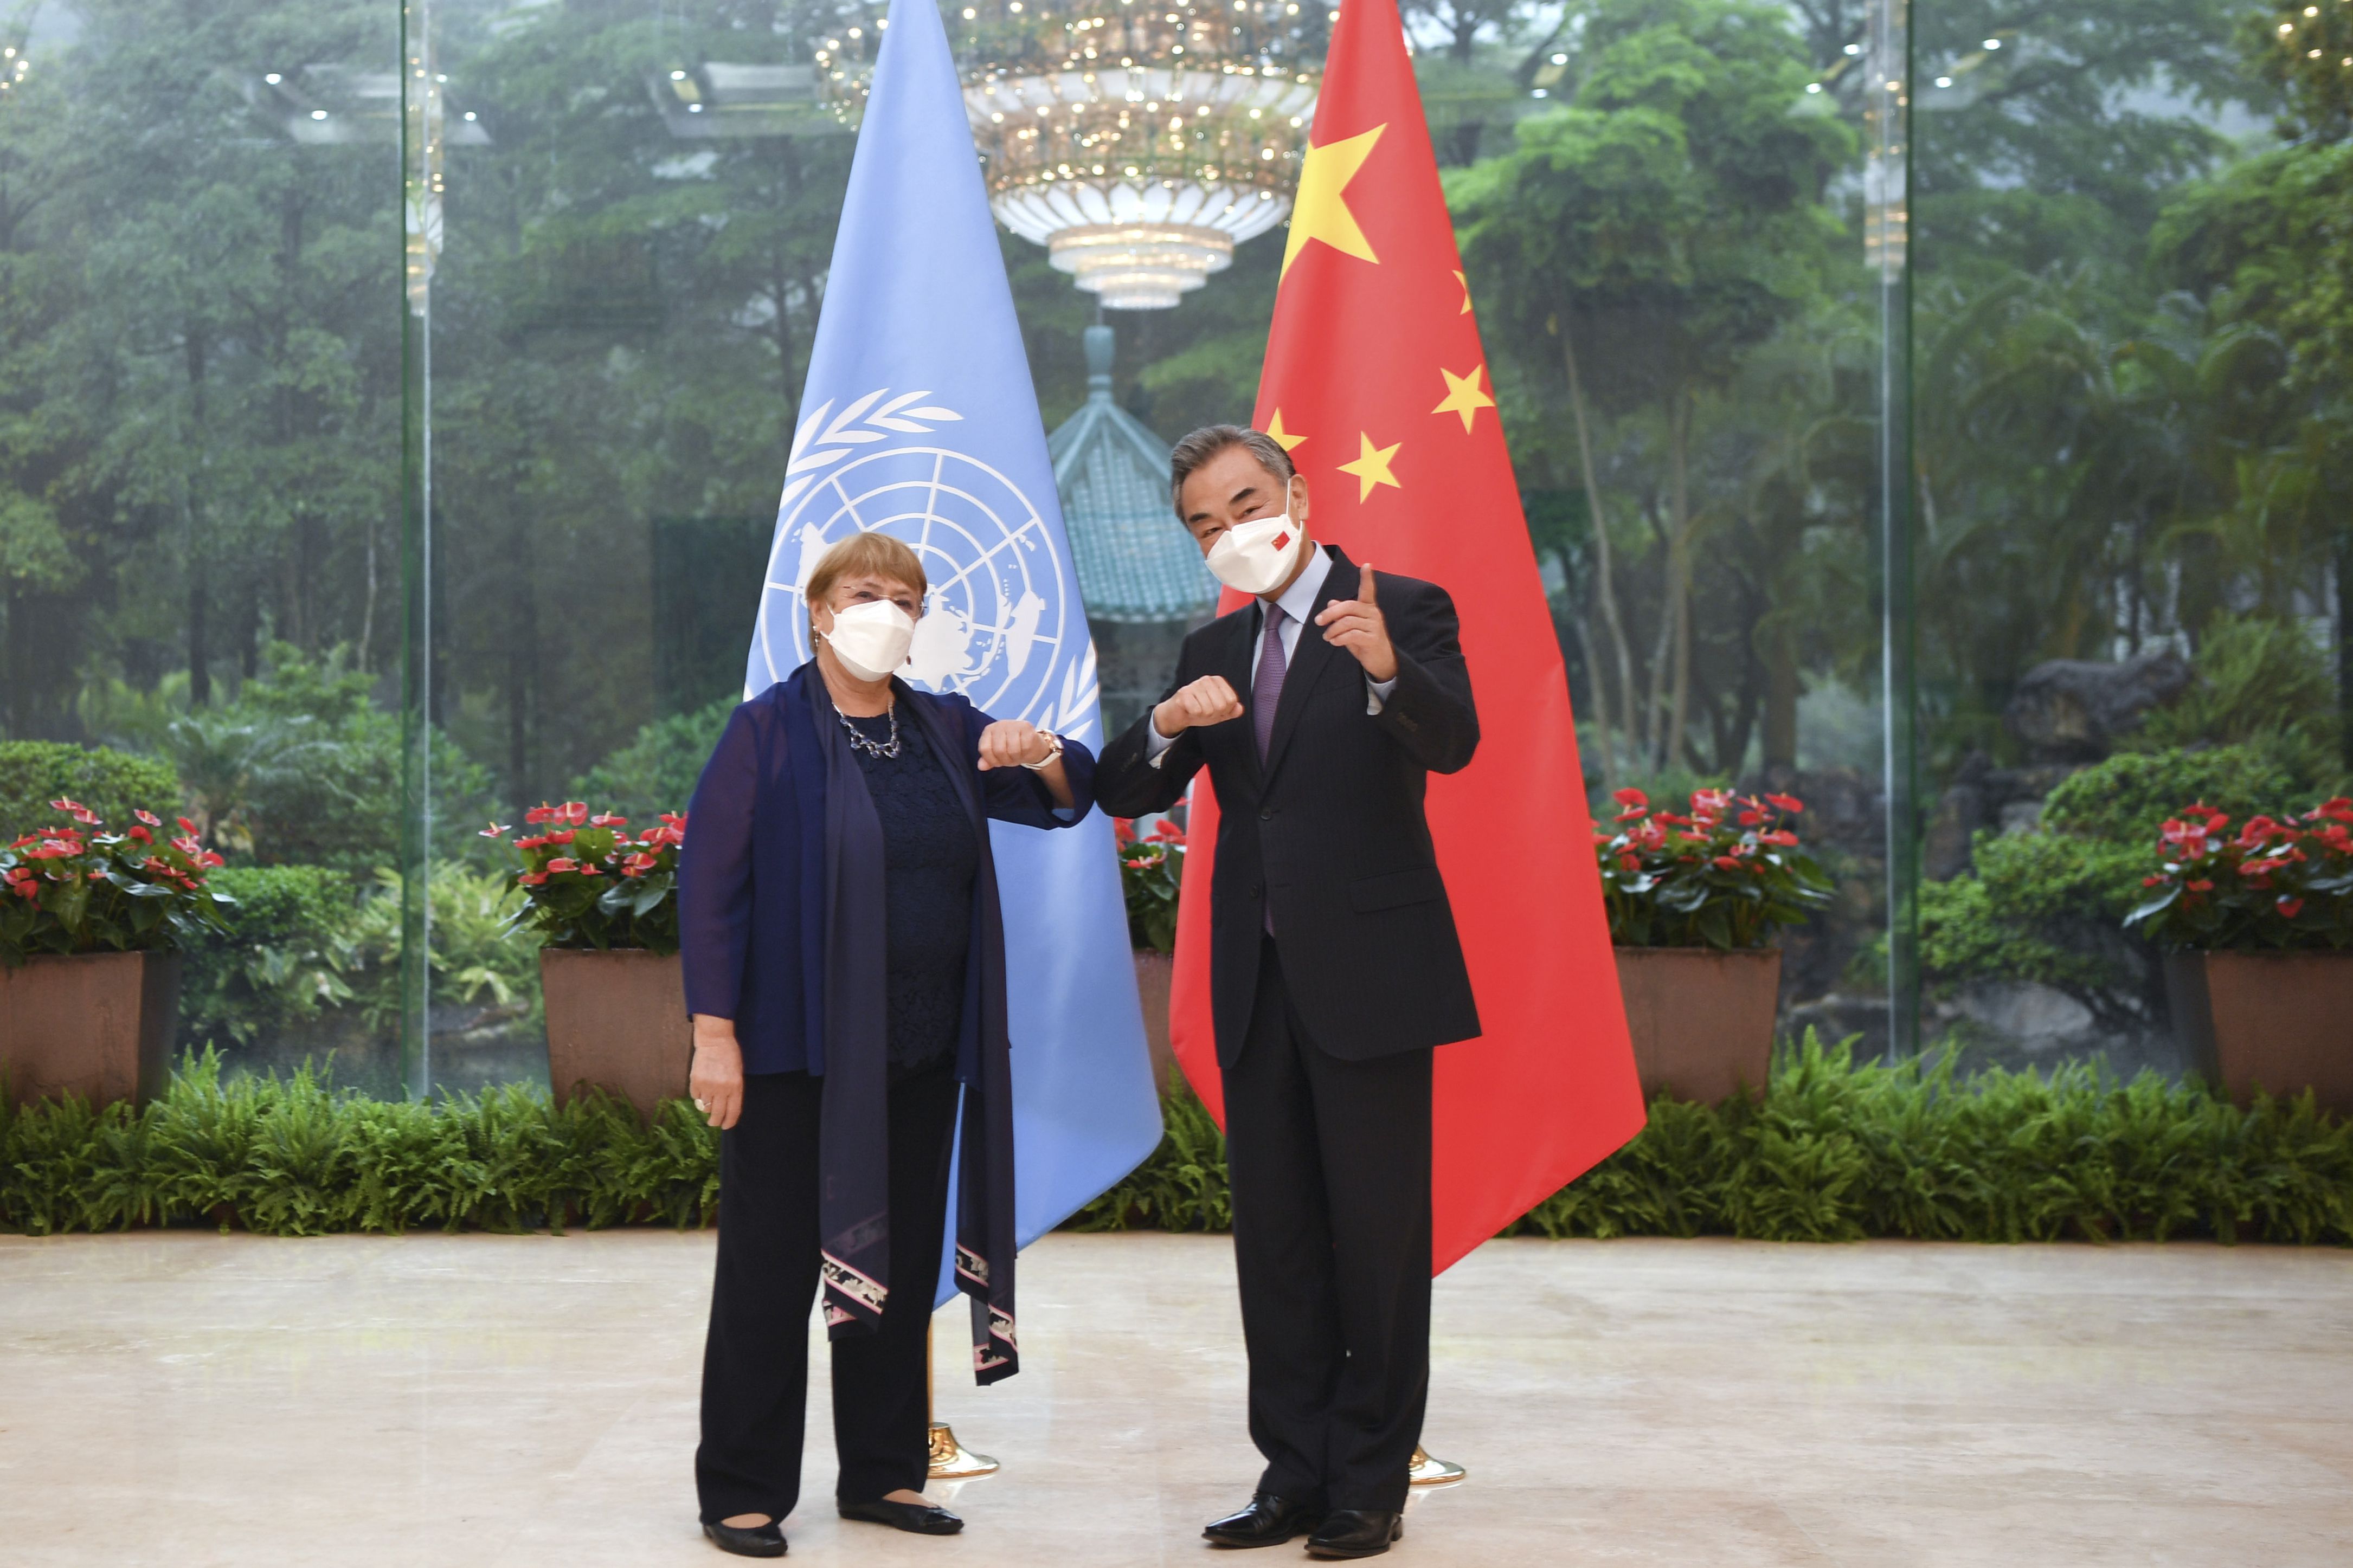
[2165,952,2353,1117]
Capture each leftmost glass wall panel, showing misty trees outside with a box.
[0,0,400,1088]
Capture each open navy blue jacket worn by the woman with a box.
[678,672,1094,1076]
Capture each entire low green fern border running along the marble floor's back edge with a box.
[0,1034,2353,1246]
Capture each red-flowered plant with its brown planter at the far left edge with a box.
[0,799,233,1105]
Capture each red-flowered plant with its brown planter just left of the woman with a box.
[483,799,694,1121]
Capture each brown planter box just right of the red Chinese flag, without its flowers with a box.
[1614,947,1781,1105]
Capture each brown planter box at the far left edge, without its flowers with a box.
[0,952,179,1105]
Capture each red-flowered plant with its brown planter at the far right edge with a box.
[2125,799,2353,1114]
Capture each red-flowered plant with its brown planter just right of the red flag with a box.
[1593,790,1831,1105]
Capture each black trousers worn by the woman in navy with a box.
[694,1065,957,1524]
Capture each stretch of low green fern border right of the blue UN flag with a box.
[1073,1032,2353,1246]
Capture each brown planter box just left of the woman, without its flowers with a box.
[539,947,694,1119]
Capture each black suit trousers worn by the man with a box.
[1226,938,1431,1509]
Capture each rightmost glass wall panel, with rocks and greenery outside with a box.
[1913,0,2353,1072]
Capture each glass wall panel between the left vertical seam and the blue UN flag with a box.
[407,0,857,1086]
